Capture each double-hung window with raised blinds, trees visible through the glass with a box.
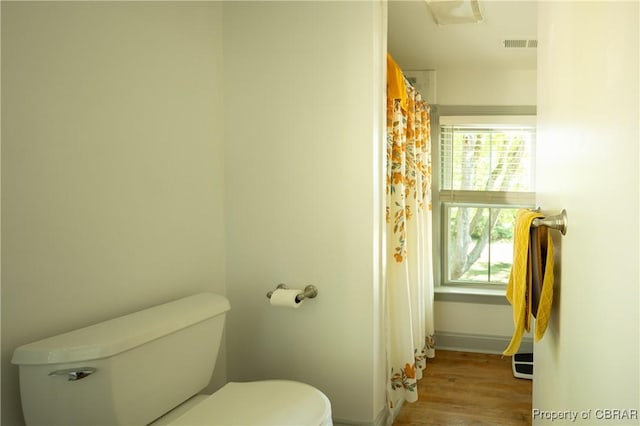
[436,116,535,289]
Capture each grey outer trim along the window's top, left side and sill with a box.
[431,105,537,304]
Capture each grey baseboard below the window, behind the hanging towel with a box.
[434,331,533,356]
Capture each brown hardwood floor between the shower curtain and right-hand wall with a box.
[393,350,532,426]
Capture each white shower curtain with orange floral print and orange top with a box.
[385,55,435,409]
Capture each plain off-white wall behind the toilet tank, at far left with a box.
[2,2,225,425]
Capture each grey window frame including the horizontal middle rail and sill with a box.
[431,105,536,304]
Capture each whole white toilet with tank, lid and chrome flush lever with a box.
[11,293,332,426]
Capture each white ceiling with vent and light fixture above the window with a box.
[388,0,537,70]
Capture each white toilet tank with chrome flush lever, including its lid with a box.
[11,293,230,426]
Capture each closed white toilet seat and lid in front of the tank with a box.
[170,380,332,426]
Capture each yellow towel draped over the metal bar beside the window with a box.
[503,210,553,355]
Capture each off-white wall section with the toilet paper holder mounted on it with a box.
[224,2,386,424]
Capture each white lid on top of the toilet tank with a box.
[11,293,231,365]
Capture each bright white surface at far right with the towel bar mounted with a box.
[533,2,640,424]
